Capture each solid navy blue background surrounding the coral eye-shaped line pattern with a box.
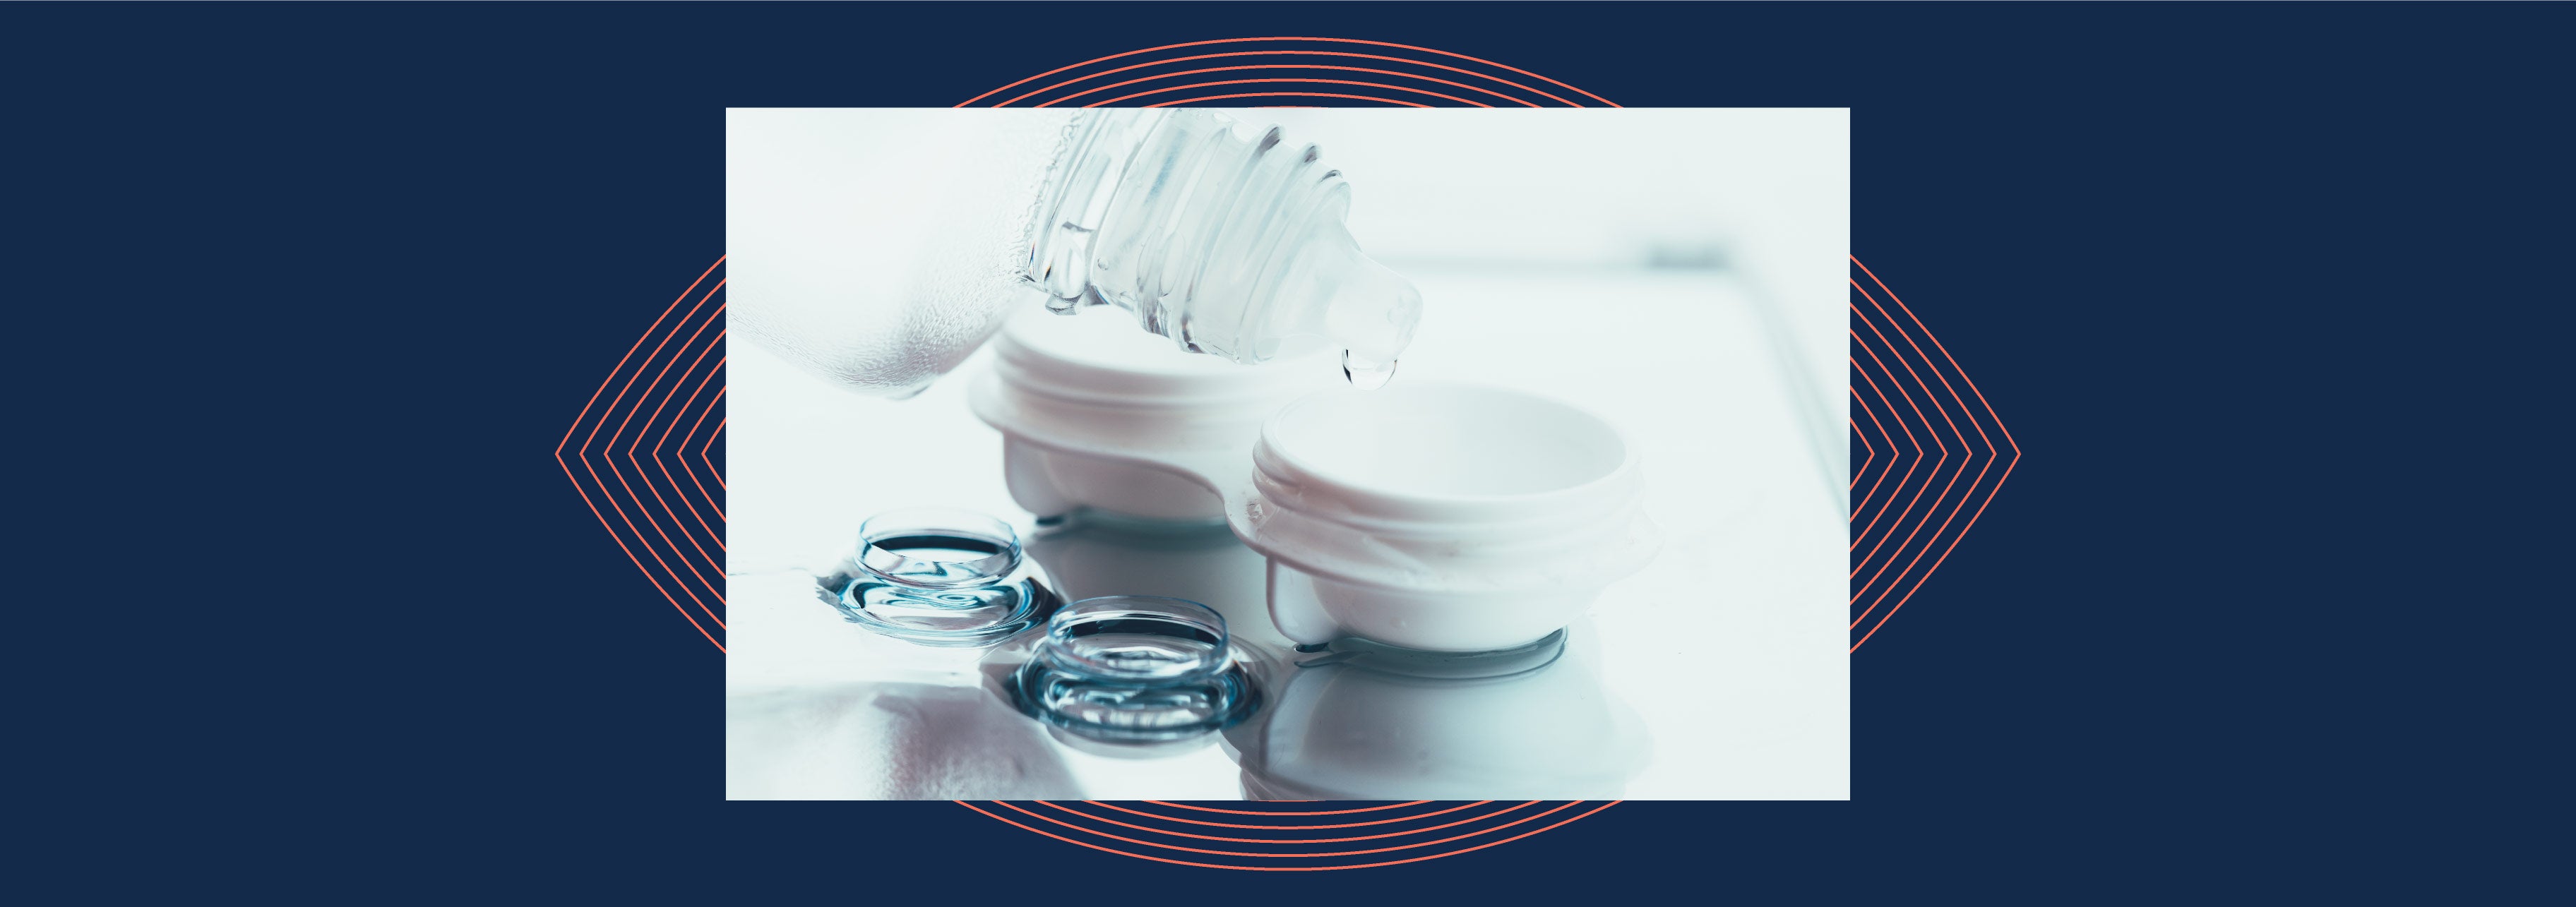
[0,3,2571,902]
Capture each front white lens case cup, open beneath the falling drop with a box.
[1229,381,1659,652]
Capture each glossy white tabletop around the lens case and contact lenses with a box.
[727,268,1849,799]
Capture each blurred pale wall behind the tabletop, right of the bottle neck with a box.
[1257,108,1849,286]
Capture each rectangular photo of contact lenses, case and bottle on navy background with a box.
[724,108,1849,801]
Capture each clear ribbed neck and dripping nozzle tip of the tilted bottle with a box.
[1020,108,1419,364]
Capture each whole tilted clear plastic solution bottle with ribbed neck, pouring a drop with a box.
[727,108,1422,397]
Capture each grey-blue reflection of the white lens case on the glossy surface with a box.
[1028,512,1651,799]
